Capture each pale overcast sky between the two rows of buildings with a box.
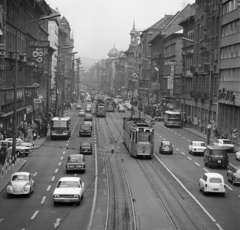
[45,0,195,59]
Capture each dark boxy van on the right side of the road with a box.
[203,146,229,168]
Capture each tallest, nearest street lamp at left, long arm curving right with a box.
[12,14,61,160]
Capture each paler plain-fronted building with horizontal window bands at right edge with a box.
[217,0,240,143]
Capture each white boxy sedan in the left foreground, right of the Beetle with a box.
[53,177,85,205]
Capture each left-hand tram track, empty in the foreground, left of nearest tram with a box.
[96,115,137,230]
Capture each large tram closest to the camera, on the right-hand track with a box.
[123,117,154,158]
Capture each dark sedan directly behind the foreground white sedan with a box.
[66,154,86,172]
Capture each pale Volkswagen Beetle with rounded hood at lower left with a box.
[7,172,35,197]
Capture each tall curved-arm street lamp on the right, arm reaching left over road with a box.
[182,37,212,145]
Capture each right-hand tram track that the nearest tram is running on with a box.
[108,110,207,230]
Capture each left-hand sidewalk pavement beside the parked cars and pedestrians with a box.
[0,136,48,195]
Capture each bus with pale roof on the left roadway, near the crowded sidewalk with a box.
[50,117,71,140]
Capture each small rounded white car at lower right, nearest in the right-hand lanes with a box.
[199,173,226,196]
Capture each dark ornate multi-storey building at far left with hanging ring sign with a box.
[0,0,52,130]
